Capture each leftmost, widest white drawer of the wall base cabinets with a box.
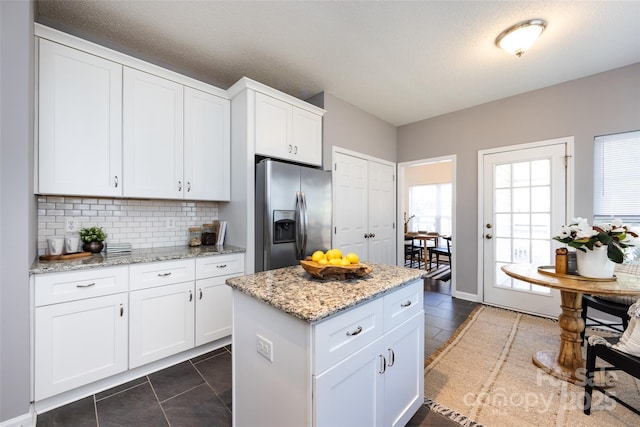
[35,267,129,307]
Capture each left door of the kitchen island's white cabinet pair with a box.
[313,338,385,427]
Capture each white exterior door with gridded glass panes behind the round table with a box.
[480,139,572,316]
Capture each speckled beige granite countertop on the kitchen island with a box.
[226,264,426,323]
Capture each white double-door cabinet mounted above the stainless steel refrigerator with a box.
[255,92,322,165]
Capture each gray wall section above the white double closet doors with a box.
[307,92,396,169]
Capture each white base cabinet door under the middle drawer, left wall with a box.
[129,282,195,368]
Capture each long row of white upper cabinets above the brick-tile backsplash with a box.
[35,24,231,201]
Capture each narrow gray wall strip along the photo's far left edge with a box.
[0,1,36,423]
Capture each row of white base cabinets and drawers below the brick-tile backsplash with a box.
[32,253,244,402]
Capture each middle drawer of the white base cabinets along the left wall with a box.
[129,260,196,291]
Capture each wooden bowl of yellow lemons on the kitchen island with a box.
[300,249,373,280]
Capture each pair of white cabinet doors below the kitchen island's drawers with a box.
[314,312,424,427]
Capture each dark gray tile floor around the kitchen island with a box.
[37,279,477,427]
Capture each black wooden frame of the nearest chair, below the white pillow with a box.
[584,337,640,415]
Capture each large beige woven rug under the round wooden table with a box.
[424,306,640,427]
